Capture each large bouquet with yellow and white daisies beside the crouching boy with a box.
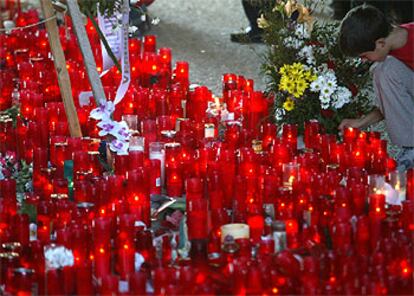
[258,0,372,134]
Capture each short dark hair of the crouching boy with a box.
[339,5,392,56]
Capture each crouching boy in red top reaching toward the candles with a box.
[338,5,414,171]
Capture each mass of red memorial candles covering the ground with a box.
[0,11,414,295]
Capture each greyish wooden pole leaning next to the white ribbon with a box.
[66,0,106,106]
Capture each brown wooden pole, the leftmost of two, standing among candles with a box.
[40,0,82,137]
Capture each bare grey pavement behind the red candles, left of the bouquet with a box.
[148,0,266,95]
